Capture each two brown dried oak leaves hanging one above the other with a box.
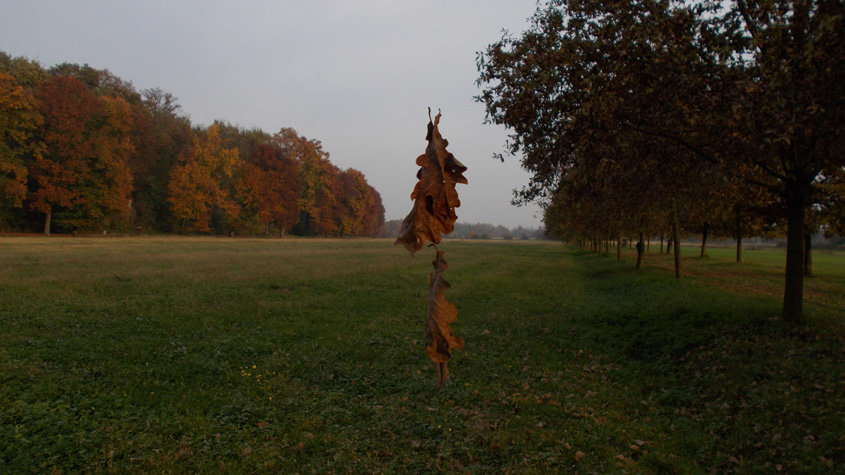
[395,109,467,388]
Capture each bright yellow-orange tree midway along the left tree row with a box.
[168,125,240,232]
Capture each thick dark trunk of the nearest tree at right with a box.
[783,193,806,325]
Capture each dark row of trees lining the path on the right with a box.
[478,0,845,323]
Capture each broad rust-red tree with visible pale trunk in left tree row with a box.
[29,76,132,235]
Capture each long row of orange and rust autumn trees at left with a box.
[0,52,384,236]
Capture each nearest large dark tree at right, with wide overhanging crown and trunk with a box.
[479,0,845,322]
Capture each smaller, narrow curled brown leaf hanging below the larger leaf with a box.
[425,251,466,388]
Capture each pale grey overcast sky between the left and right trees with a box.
[0,0,541,227]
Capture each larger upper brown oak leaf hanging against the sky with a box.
[395,109,467,254]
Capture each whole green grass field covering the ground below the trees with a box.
[0,237,845,474]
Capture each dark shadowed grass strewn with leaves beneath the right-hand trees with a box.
[556,247,845,473]
